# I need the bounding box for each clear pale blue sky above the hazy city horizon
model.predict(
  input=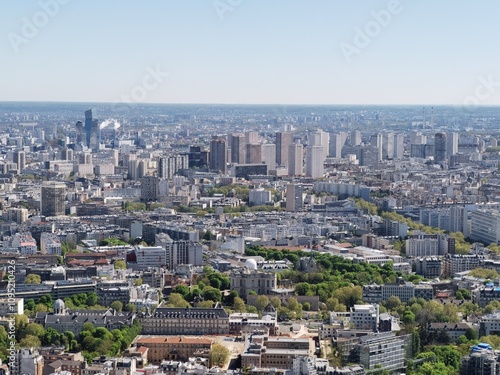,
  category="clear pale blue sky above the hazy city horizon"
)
[0,0,500,105]
